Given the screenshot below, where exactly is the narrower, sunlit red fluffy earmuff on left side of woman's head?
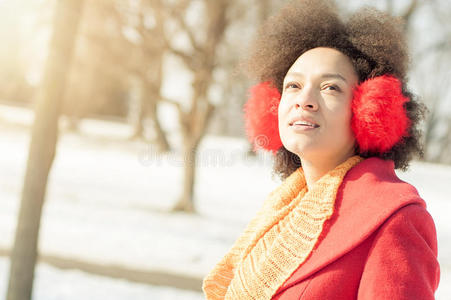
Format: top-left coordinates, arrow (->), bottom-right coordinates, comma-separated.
244,81 -> 282,153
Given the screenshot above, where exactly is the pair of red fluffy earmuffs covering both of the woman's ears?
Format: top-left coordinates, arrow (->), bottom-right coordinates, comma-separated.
244,75 -> 410,153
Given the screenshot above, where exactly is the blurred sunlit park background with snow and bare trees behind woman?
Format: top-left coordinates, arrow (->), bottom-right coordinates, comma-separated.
0,0 -> 451,300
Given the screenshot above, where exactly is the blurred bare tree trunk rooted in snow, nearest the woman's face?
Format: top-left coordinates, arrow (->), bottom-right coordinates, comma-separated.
168,0 -> 229,213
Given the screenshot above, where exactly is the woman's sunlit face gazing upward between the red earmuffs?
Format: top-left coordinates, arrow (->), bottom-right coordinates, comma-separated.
278,47 -> 358,161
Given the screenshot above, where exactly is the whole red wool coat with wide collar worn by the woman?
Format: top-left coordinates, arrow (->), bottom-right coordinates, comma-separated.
272,158 -> 440,300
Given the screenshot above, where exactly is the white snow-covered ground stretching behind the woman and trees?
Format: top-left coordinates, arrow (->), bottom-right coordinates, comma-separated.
0,106 -> 451,300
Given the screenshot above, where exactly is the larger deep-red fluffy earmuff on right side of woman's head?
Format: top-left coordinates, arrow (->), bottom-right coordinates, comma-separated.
351,75 -> 410,153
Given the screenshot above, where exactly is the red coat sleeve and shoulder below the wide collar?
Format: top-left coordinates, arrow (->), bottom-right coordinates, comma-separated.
358,204 -> 440,300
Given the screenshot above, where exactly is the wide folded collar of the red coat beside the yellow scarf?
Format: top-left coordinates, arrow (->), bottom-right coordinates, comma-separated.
276,158 -> 426,294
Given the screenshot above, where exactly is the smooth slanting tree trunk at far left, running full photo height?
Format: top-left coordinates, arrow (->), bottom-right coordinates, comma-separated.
7,0 -> 83,300
